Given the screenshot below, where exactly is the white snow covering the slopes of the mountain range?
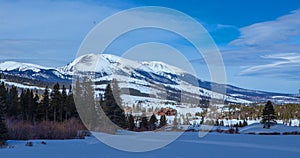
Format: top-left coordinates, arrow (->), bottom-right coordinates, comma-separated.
0,54 -> 299,104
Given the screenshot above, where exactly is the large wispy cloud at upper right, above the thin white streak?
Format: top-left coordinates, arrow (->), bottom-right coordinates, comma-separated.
230,10 -> 300,46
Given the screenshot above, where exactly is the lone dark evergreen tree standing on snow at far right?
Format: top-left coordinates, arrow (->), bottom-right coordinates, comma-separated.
261,101 -> 275,128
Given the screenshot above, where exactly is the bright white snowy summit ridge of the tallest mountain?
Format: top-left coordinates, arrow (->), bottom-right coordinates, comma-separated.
58,54 -> 187,74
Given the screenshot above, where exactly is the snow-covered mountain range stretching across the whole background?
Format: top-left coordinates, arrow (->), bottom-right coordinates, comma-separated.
0,54 -> 298,103
